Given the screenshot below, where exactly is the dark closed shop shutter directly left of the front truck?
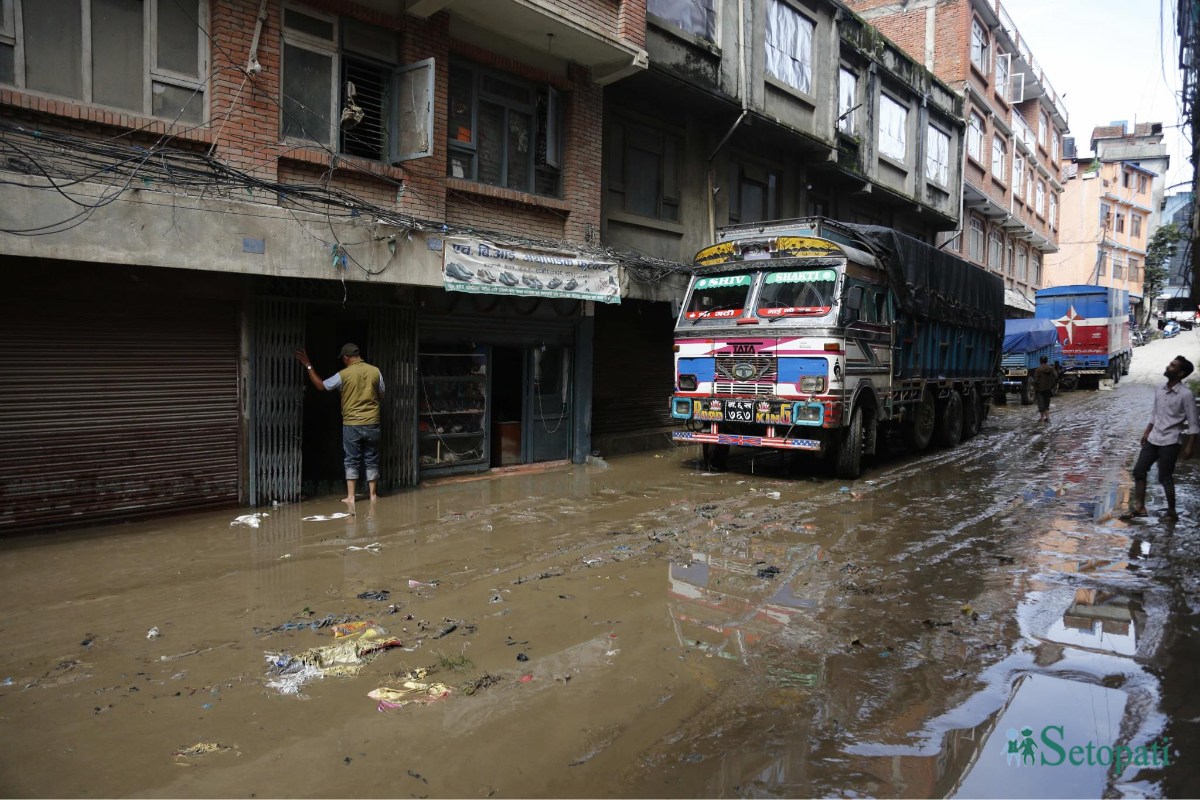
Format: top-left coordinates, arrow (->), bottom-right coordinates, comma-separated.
592,300 -> 674,438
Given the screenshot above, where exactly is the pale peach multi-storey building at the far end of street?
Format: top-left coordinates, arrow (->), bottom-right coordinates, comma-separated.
1045,122 -> 1169,315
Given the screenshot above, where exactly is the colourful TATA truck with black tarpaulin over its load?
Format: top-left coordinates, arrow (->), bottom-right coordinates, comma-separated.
670,217 -> 1004,479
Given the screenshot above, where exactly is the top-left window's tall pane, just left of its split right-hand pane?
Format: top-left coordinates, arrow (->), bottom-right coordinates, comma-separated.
91,0 -> 145,114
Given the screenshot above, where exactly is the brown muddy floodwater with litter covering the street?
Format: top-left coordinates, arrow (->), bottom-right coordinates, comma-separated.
0,333 -> 1200,798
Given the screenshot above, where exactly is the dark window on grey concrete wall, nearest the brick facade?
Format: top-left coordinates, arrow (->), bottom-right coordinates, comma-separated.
606,121 -> 683,222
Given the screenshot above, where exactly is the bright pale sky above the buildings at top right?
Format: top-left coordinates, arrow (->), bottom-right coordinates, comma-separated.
1001,0 -> 1192,192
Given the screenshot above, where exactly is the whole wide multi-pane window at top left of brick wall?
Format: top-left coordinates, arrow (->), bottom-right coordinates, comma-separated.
0,0 -> 208,125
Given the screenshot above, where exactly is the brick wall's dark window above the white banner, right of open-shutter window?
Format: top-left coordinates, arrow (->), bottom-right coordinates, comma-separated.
446,64 -> 562,197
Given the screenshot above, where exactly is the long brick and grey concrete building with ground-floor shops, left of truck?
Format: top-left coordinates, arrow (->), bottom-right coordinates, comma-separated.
0,0 -> 964,533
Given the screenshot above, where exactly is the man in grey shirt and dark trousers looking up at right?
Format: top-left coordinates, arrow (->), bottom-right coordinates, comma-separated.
1129,355 -> 1200,522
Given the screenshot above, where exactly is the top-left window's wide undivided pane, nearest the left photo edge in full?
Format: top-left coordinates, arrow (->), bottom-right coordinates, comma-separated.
22,0 -> 83,100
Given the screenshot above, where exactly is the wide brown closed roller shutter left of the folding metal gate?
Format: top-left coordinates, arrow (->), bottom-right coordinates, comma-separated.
0,294 -> 239,534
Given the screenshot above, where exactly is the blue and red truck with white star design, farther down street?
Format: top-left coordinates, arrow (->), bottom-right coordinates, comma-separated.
1033,284 -> 1133,387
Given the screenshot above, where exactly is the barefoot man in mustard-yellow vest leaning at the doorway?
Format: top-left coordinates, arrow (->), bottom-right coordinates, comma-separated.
295,342 -> 384,513
